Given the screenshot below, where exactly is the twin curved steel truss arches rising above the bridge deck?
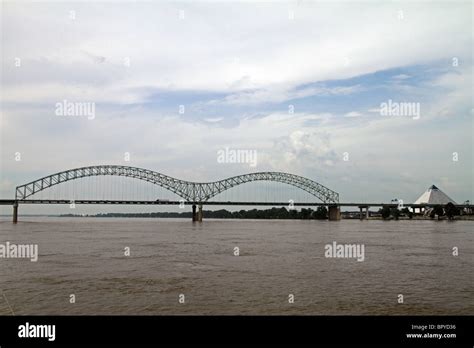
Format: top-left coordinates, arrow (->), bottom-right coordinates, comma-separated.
15,165 -> 339,204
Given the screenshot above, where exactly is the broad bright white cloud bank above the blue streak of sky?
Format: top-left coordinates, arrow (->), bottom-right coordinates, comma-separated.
2,2 -> 470,103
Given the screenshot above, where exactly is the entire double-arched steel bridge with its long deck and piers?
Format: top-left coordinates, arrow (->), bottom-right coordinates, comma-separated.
0,165 -> 470,223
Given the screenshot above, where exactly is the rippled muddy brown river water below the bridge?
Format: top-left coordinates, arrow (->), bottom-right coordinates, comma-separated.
0,217 -> 474,315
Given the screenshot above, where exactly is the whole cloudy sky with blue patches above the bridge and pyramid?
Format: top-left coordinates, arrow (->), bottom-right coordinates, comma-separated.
0,1 -> 474,212
